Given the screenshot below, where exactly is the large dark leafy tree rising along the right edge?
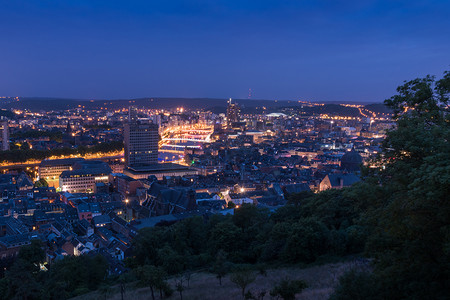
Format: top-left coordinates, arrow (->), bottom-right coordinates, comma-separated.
365,72 -> 450,299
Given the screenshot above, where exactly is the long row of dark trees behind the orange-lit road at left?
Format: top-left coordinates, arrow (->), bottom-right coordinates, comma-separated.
0,141 -> 123,163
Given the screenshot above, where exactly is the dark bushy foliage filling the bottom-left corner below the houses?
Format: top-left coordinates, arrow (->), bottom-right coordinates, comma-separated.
0,240 -> 107,299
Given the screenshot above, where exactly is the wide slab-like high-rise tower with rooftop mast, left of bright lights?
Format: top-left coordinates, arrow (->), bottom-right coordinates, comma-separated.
124,107 -> 159,167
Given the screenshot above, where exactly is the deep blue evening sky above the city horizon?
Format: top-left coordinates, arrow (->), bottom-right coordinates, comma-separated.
0,0 -> 450,102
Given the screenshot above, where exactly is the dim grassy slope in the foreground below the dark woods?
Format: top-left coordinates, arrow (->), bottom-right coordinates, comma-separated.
73,261 -> 370,300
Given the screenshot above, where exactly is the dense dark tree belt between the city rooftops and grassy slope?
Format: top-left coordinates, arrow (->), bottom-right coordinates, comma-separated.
128,189 -> 372,274
